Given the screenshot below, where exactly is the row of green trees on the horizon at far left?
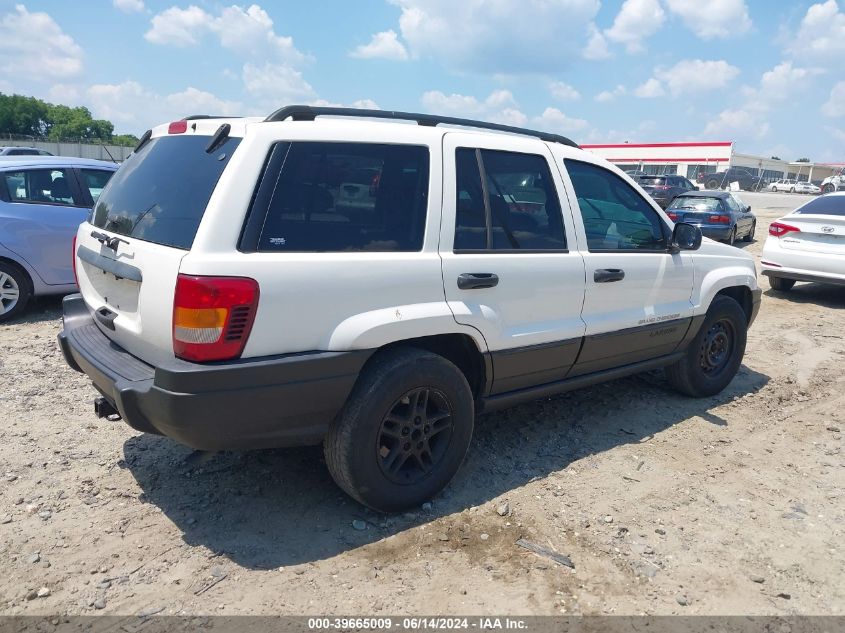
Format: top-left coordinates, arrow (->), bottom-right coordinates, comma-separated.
0,92 -> 138,146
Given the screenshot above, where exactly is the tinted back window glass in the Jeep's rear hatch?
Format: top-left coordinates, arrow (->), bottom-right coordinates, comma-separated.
92,135 -> 240,250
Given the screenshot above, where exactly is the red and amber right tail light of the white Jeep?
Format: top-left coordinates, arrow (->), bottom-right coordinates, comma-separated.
173,275 -> 259,362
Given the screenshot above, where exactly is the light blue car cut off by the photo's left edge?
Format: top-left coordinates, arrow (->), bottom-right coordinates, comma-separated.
0,156 -> 117,322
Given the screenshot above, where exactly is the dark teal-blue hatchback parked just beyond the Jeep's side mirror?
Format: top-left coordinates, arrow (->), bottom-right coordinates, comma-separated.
666,190 -> 757,244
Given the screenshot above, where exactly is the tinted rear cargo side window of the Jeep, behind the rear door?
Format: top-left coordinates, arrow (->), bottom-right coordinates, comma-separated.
258,142 -> 429,252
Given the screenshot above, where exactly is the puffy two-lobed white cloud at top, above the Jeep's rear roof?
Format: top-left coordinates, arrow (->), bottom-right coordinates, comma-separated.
144,4 -> 307,64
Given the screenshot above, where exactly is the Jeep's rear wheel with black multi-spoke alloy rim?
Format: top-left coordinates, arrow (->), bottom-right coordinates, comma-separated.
324,347 -> 475,512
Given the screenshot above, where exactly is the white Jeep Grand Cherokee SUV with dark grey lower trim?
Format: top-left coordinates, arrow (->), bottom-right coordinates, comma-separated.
59,106 -> 760,511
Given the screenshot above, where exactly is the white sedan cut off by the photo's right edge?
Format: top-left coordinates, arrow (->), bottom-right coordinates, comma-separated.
761,191 -> 845,291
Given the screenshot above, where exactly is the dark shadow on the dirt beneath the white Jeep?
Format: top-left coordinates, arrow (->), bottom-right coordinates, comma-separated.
121,366 -> 769,569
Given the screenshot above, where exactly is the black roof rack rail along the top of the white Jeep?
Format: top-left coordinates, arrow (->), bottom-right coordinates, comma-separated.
264,105 -> 578,147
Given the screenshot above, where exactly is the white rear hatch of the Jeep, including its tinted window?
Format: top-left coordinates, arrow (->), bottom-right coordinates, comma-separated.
75,120 -> 244,363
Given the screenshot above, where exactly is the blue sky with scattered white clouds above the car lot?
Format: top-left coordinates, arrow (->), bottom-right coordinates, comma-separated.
0,0 -> 845,162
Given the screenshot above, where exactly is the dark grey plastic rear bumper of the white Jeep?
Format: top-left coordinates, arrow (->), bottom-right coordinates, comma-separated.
59,294 -> 372,450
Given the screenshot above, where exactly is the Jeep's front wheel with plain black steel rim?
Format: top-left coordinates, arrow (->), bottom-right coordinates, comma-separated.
666,295 -> 748,398
